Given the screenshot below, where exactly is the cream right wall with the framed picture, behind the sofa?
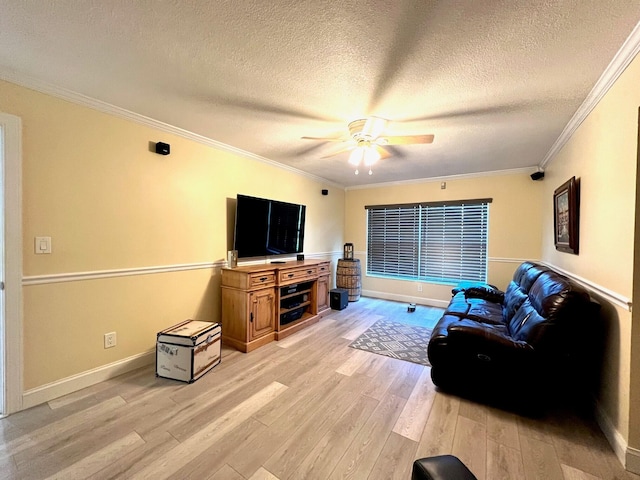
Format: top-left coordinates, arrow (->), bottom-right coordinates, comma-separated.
542,54 -> 640,448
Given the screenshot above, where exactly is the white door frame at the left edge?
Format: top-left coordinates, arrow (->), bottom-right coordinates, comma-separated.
0,112 -> 23,415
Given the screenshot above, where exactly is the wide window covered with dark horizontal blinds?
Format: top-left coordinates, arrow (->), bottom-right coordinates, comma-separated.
365,199 -> 491,283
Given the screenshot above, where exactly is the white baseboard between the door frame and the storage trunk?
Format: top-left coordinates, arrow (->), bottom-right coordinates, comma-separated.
22,348 -> 155,410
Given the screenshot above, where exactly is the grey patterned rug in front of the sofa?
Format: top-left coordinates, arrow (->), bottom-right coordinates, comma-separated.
349,320 -> 431,366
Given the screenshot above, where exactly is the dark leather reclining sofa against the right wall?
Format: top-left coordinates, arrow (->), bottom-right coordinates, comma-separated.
428,262 -> 599,406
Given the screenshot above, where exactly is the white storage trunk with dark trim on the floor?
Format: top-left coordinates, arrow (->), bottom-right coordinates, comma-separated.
156,320 -> 221,383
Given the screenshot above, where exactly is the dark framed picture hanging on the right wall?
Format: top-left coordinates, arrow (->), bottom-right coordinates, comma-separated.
553,177 -> 580,255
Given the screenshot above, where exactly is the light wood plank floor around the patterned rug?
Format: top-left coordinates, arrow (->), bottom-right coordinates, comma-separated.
0,298 -> 640,480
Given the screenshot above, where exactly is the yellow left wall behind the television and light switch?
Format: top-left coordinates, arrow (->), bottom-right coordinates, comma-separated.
0,82 -> 344,389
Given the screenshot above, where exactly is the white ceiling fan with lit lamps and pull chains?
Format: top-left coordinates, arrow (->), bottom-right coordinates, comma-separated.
302,117 -> 433,175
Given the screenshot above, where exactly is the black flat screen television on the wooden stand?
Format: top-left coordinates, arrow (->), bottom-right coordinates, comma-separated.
233,195 -> 307,258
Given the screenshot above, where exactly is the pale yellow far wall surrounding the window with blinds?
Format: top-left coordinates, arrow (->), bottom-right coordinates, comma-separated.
345,173 -> 544,305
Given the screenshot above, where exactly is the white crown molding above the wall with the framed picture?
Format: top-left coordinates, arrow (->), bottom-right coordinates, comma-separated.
540,23 -> 640,168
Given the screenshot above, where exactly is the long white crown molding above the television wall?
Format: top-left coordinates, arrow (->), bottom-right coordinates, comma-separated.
0,67 -> 344,188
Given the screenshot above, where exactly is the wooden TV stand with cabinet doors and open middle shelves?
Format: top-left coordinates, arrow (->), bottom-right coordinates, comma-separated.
221,260 -> 331,353
